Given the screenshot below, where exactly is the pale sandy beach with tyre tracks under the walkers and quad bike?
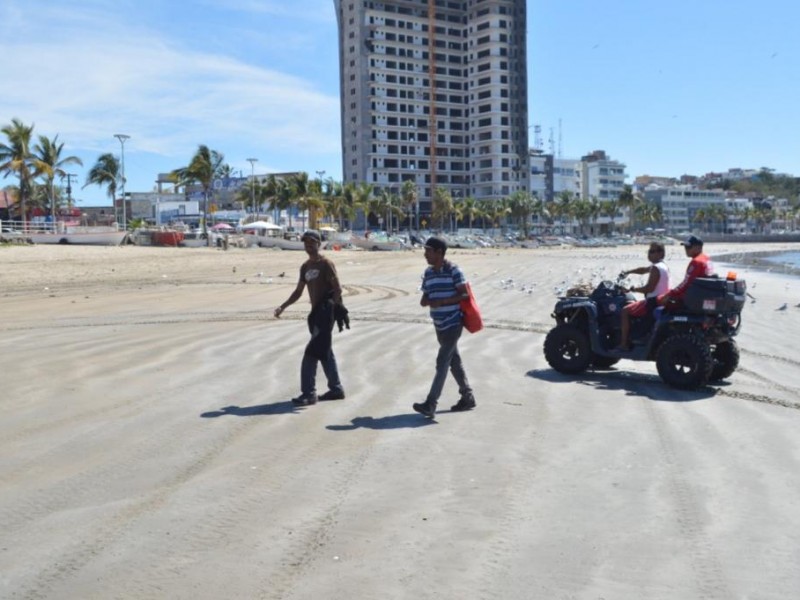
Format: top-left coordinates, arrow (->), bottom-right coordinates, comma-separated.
0,244 -> 800,600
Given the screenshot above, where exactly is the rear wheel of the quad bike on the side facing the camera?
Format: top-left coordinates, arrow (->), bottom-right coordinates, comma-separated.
656,333 -> 714,389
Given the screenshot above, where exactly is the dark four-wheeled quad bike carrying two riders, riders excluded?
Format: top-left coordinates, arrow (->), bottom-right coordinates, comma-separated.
544,274 -> 747,389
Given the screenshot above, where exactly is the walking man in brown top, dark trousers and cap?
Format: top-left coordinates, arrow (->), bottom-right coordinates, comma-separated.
275,230 -> 344,406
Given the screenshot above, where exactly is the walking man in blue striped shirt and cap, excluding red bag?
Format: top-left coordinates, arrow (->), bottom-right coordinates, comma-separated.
413,237 -> 475,418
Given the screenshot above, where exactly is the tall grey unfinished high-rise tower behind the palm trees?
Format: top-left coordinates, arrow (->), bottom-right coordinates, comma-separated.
334,0 -> 529,219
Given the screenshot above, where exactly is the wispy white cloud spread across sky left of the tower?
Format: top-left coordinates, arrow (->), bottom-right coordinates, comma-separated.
0,2 -> 339,161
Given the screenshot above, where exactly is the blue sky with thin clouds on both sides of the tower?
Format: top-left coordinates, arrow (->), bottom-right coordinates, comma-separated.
0,0 -> 800,204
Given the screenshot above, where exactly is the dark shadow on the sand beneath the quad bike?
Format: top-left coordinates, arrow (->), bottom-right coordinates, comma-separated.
526,369 -> 724,402
